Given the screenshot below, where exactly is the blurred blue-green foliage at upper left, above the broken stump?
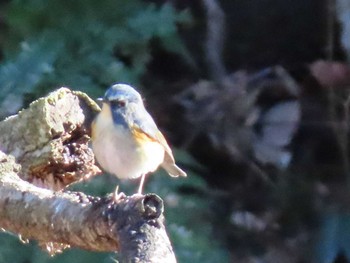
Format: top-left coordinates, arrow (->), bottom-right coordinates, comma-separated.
0,0 -> 191,115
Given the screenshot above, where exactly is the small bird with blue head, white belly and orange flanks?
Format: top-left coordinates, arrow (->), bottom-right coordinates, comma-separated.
92,84 -> 186,194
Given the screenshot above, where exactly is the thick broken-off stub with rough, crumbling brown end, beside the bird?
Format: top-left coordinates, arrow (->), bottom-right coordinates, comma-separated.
0,88 -> 99,190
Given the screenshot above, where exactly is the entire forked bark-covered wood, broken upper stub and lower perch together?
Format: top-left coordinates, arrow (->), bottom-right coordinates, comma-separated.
0,88 -> 176,262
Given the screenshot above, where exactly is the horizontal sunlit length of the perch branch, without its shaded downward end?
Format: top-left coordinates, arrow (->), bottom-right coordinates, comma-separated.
0,153 -> 118,251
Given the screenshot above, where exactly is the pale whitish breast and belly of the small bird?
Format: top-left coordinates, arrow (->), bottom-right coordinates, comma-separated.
92,115 -> 164,179
